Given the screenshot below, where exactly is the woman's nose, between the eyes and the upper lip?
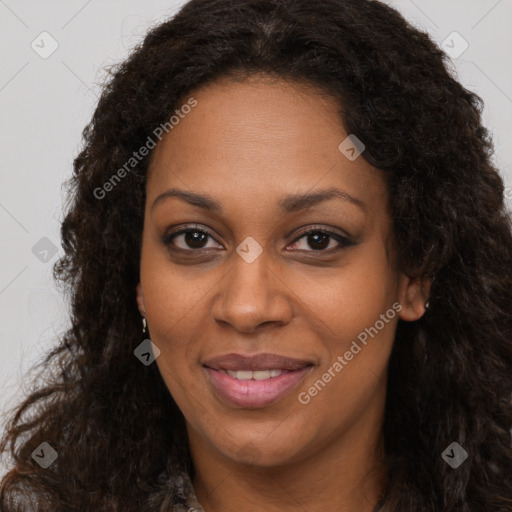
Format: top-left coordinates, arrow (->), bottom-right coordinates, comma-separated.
212,251 -> 293,333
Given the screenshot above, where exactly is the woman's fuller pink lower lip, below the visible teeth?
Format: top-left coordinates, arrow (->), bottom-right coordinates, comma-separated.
205,366 -> 312,408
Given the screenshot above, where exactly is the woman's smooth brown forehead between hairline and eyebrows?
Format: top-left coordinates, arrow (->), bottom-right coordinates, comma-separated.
147,74 -> 387,214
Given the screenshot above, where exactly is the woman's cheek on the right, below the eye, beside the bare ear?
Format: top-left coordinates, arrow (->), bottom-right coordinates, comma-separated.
298,240 -> 400,396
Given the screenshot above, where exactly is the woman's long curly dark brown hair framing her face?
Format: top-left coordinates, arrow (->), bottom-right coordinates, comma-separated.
0,0 -> 512,512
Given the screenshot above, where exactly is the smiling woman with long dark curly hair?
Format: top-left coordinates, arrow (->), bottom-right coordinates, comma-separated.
0,0 -> 512,512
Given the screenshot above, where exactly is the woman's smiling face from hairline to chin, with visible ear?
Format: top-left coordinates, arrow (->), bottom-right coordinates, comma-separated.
137,75 -> 426,466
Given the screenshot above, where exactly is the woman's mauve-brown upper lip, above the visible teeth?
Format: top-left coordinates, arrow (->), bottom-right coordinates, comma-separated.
203,353 -> 313,370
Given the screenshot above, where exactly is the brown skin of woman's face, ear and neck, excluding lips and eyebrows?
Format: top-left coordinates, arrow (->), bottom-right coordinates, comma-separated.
137,76 -> 430,512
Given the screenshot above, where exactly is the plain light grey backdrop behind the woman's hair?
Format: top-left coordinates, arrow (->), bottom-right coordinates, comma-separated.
0,0 -> 512,475
